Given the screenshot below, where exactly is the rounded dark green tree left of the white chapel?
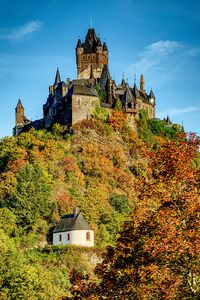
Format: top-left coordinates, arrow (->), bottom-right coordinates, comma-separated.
7,163 -> 52,231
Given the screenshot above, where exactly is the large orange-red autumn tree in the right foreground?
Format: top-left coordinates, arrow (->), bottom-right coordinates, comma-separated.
70,135 -> 200,300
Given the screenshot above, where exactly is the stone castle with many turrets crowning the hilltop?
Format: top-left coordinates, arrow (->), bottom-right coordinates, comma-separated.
13,28 -> 155,135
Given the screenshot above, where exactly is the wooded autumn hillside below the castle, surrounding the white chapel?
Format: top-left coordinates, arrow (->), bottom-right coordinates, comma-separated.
0,108 -> 199,299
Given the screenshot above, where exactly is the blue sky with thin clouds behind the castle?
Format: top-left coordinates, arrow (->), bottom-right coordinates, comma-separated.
0,0 -> 200,137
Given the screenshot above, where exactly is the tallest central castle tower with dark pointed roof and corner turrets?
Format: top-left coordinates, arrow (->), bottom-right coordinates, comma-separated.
76,28 -> 108,79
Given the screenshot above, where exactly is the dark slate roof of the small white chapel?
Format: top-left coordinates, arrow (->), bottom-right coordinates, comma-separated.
53,212 -> 93,233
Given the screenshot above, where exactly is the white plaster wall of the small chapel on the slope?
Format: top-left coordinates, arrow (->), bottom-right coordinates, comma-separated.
53,230 -> 94,247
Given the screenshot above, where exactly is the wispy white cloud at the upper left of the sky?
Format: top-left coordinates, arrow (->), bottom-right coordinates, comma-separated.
0,21 -> 42,41
